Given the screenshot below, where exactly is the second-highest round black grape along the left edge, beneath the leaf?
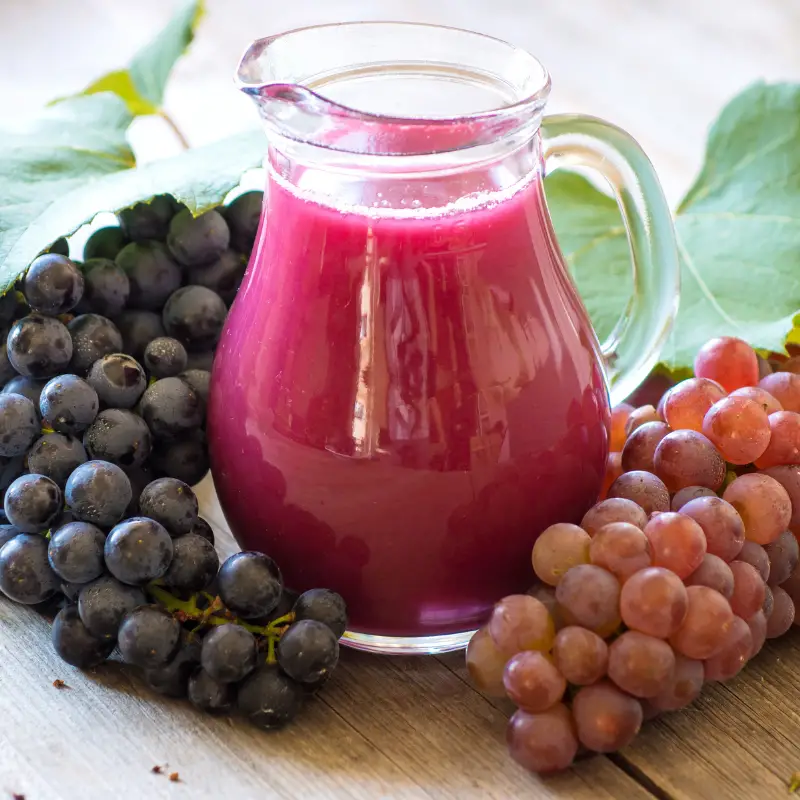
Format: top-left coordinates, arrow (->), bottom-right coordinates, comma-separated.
7,314 -> 72,378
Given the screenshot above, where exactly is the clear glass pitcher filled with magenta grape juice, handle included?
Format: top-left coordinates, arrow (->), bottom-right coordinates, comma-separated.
208,23 -> 678,653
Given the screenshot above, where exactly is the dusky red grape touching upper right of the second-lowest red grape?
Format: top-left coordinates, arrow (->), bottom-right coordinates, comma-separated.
608,631 -> 675,697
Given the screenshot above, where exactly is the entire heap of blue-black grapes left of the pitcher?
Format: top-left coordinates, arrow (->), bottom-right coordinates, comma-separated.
0,192 -> 347,729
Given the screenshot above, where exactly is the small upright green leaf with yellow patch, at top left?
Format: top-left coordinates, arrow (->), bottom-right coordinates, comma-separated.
66,0 -> 205,116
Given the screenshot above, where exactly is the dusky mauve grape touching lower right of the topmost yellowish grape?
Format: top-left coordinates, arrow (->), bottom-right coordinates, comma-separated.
556,564 -> 621,638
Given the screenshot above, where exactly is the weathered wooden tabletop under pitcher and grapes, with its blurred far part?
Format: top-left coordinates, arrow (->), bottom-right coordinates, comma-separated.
0,0 -> 800,800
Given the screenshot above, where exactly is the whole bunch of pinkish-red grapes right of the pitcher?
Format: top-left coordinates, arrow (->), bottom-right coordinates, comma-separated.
467,337 -> 800,773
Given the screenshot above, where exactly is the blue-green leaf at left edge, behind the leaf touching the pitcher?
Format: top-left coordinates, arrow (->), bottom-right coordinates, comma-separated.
0,94 -> 135,284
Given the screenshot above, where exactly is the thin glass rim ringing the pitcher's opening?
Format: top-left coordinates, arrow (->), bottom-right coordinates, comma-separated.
234,20 -> 552,127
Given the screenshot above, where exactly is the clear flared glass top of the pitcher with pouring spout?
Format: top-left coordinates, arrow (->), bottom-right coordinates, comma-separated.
236,22 -> 550,156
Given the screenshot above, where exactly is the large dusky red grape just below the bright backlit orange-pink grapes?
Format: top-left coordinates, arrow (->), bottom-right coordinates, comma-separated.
653,430 -> 725,493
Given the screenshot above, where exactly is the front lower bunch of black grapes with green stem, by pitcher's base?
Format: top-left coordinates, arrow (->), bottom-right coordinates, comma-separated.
0,461 -> 347,728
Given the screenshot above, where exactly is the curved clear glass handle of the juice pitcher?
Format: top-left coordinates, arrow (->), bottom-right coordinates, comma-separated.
542,114 -> 680,406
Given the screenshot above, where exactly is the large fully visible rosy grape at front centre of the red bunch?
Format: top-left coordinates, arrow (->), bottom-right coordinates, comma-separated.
619,567 -> 689,639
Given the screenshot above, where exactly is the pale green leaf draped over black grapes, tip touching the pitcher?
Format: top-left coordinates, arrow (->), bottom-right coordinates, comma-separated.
0,128 -> 266,293
